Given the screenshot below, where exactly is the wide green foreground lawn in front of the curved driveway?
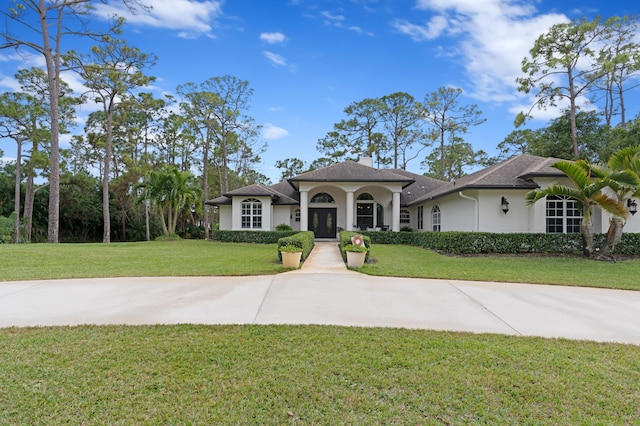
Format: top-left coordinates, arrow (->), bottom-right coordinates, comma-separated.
0,325 -> 640,425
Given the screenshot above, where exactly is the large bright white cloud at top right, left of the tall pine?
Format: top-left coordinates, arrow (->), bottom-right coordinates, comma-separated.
396,0 -> 568,102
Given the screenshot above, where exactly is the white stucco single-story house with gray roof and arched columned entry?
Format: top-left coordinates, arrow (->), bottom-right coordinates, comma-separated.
207,155 -> 640,238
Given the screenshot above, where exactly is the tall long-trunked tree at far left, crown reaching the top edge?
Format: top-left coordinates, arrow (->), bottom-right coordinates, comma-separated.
0,0 -> 144,243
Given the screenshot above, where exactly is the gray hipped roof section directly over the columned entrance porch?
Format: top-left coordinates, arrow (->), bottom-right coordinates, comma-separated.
289,161 -> 415,189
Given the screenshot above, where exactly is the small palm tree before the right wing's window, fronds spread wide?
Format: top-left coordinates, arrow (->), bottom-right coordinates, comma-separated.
526,160 -> 627,256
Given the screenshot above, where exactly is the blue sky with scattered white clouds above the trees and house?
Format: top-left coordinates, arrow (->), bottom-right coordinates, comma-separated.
0,0 -> 640,182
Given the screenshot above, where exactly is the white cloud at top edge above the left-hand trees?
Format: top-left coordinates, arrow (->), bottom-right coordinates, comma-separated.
95,0 -> 222,38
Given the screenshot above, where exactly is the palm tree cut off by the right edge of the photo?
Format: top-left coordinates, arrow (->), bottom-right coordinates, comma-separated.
592,145 -> 640,256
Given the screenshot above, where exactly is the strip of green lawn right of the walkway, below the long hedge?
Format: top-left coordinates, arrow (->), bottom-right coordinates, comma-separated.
359,244 -> 640,290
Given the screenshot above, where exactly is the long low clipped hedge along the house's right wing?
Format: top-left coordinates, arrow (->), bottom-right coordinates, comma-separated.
361,232 -> 640,256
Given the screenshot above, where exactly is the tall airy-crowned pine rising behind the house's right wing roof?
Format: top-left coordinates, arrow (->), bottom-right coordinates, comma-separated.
515,17 -> 604,158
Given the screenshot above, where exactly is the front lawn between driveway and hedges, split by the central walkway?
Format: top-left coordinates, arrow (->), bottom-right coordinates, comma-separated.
0,240 -> 640,290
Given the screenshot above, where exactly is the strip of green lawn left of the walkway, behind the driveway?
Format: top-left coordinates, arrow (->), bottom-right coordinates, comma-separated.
0,240 -> 284,281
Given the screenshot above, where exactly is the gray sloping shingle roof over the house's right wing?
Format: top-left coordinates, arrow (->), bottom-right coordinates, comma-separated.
409,154 -> 564,204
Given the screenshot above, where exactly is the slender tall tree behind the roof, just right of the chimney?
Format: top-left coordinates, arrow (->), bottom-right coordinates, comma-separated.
423,87 -> 486,180
